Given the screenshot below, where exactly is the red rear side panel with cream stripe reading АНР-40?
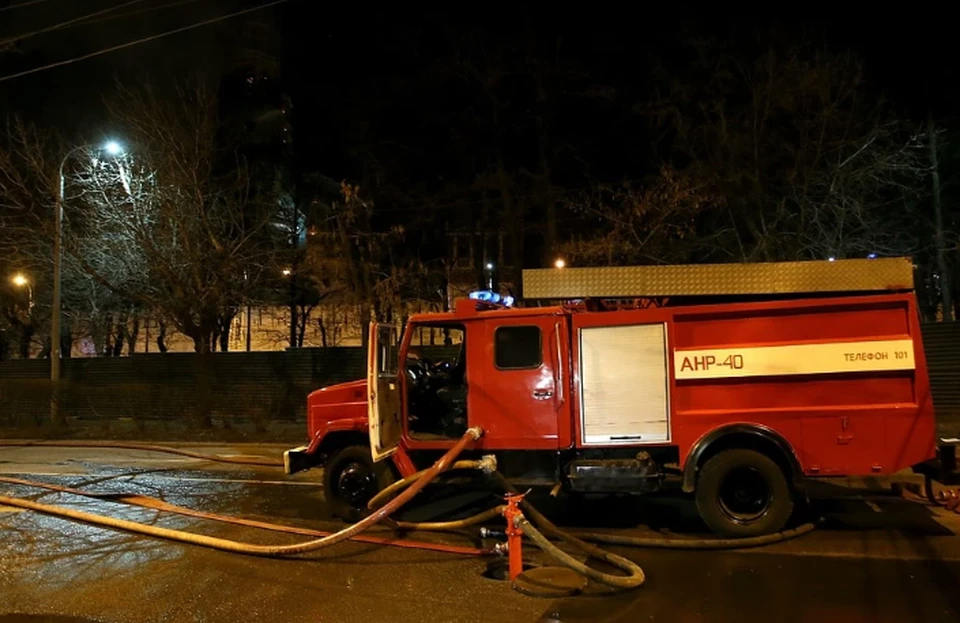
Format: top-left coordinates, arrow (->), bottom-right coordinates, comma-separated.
672,295 -> 934,475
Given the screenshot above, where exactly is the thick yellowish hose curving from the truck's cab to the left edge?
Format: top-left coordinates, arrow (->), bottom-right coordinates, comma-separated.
0,428 -> 483,556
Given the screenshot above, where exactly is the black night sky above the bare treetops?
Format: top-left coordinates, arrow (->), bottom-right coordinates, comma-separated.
0,0 -> 960,177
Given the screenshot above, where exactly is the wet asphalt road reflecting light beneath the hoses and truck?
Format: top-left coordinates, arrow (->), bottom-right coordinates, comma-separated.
0,448 -> 960,623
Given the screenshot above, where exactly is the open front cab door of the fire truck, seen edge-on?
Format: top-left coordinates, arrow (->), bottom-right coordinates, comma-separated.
367,323 -> 403,461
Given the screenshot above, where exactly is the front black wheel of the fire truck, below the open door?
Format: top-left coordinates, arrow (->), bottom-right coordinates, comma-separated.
323,446 -> 396,522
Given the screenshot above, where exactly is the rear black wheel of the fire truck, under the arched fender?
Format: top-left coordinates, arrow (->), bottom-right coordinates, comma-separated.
695,450 -> 793,538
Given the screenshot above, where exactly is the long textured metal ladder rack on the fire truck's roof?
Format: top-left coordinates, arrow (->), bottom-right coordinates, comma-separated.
523,257 -> 913,300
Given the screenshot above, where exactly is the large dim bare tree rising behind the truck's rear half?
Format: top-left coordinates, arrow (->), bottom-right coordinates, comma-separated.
643,40 -> 928,261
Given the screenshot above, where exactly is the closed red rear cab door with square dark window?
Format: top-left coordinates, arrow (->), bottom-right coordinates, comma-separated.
469,316 -> 570,450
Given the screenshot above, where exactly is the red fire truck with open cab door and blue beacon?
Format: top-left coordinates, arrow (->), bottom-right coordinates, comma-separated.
285,258 -> 956,536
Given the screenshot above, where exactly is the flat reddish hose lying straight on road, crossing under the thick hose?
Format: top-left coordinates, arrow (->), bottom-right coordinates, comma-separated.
0,476 -> 493,556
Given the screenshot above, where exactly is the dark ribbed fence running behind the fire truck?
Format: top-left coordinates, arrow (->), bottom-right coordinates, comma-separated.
0,322 -> 960,436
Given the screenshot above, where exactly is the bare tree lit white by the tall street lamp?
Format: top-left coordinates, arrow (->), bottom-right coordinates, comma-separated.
64,79 -> 275,353
